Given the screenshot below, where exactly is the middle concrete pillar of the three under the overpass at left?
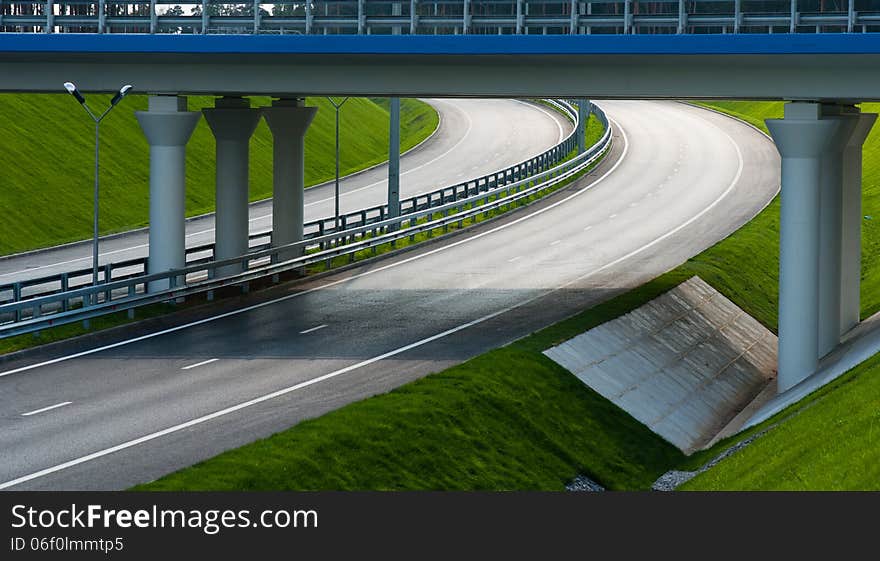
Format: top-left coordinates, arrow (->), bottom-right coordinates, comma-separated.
202,97 -> 260,277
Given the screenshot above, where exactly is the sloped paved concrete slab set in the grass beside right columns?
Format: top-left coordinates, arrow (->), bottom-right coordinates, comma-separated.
544,277 -> 777,454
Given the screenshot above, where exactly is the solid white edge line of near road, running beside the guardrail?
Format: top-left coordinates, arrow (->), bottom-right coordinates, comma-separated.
0,112 -> 629,378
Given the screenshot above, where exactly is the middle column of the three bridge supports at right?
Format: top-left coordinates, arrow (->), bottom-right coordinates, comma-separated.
818,105 -> 858,358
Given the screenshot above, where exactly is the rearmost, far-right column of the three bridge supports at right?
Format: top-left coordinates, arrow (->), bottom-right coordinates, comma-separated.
840,110 -> 877,335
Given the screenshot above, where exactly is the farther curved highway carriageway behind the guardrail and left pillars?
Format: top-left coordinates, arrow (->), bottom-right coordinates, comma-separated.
0,99 -> 571,284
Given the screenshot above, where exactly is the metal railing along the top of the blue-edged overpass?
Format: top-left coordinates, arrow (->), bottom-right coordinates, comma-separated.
0,0 -> 880,35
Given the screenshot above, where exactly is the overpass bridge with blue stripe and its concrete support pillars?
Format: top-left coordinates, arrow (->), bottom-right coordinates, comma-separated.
0,14 -> 880,398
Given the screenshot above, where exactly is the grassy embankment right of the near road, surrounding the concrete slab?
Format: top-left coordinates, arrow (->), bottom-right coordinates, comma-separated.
141,103 -> 880,489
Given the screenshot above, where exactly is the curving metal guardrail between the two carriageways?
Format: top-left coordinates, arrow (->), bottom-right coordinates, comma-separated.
0,100 -> 611,338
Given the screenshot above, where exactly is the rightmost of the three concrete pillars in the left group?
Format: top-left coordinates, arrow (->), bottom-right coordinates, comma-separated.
263,99 -> 318,261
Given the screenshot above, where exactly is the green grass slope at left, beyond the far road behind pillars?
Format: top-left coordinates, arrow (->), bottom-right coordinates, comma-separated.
0,94 -> 438,255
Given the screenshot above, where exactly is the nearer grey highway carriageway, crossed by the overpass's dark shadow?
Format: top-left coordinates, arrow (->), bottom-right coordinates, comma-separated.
0,101 -> 779,489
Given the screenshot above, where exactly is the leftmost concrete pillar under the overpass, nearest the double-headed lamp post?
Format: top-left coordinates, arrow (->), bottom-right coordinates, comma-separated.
135,95 -> 202,292
